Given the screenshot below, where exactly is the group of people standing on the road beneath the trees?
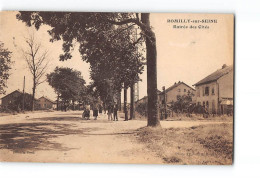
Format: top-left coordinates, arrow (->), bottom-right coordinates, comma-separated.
82,104 -> 118,121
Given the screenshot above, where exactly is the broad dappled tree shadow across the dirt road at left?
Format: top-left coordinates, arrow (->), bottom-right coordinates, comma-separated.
0,118 -> 98,153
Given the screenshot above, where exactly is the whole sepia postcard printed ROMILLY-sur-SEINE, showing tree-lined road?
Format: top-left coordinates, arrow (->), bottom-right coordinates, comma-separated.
0,11 -> 234,165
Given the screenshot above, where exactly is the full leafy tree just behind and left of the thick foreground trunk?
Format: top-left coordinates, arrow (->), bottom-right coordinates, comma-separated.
88,22 -> 144,120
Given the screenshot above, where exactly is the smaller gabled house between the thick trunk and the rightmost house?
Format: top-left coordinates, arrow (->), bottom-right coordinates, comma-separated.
159,81 -> 195,104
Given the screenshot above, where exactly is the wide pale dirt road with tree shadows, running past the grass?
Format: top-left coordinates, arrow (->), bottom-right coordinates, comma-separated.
0,111 -> 230,164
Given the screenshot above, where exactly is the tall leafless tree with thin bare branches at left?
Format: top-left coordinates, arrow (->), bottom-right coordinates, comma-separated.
22,33 -> 48,111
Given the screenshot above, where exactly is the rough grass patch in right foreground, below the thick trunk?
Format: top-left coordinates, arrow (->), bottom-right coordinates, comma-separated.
137,123 -> 233,165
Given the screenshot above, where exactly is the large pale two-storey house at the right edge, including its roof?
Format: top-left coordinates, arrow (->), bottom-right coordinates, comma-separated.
194,65 -> 233,114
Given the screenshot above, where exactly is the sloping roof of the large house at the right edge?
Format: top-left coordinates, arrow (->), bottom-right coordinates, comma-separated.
194,65 -> 233,86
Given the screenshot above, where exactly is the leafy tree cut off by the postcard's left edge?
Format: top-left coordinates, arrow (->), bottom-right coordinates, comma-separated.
0,41 -> 12,94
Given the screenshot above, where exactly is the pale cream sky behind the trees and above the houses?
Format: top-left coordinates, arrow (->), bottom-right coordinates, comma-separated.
0,11 -> 233,100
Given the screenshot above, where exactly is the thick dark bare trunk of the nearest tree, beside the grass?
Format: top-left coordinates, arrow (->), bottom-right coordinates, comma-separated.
141,13 -> 160,127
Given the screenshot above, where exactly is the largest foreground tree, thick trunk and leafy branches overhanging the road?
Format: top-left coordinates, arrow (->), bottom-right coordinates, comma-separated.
17,12 -> 160,126
